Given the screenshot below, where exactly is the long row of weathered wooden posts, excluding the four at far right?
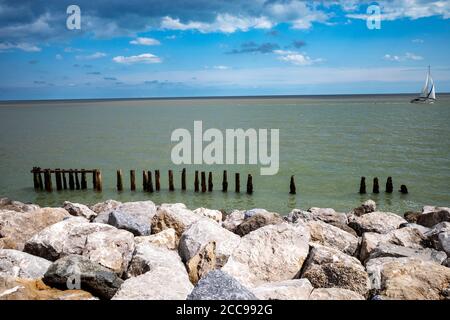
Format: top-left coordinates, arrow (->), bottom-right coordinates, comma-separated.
31,167 -> 296,194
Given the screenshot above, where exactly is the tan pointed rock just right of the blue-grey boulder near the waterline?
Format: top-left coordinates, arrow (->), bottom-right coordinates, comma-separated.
152,205 -> 206,242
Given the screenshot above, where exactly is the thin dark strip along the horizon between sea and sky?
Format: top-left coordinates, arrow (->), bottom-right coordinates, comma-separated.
0,92 -> 450,105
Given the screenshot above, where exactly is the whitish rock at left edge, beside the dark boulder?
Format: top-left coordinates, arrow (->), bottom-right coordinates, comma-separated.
0,249 -> 51,279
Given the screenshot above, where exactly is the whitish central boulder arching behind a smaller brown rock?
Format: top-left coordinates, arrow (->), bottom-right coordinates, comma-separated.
178,219 -> 241,267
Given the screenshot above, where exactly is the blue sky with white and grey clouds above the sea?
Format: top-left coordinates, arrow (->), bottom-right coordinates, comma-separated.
0,0 -> 450,100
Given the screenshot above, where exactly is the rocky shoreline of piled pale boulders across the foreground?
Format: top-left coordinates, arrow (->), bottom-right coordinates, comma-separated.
0,198 -> 450,300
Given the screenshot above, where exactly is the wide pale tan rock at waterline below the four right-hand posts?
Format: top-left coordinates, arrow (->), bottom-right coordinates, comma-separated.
349,211 -> 406,235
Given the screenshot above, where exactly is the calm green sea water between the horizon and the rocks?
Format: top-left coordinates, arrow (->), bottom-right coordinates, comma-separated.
0,95 -> 450,214
